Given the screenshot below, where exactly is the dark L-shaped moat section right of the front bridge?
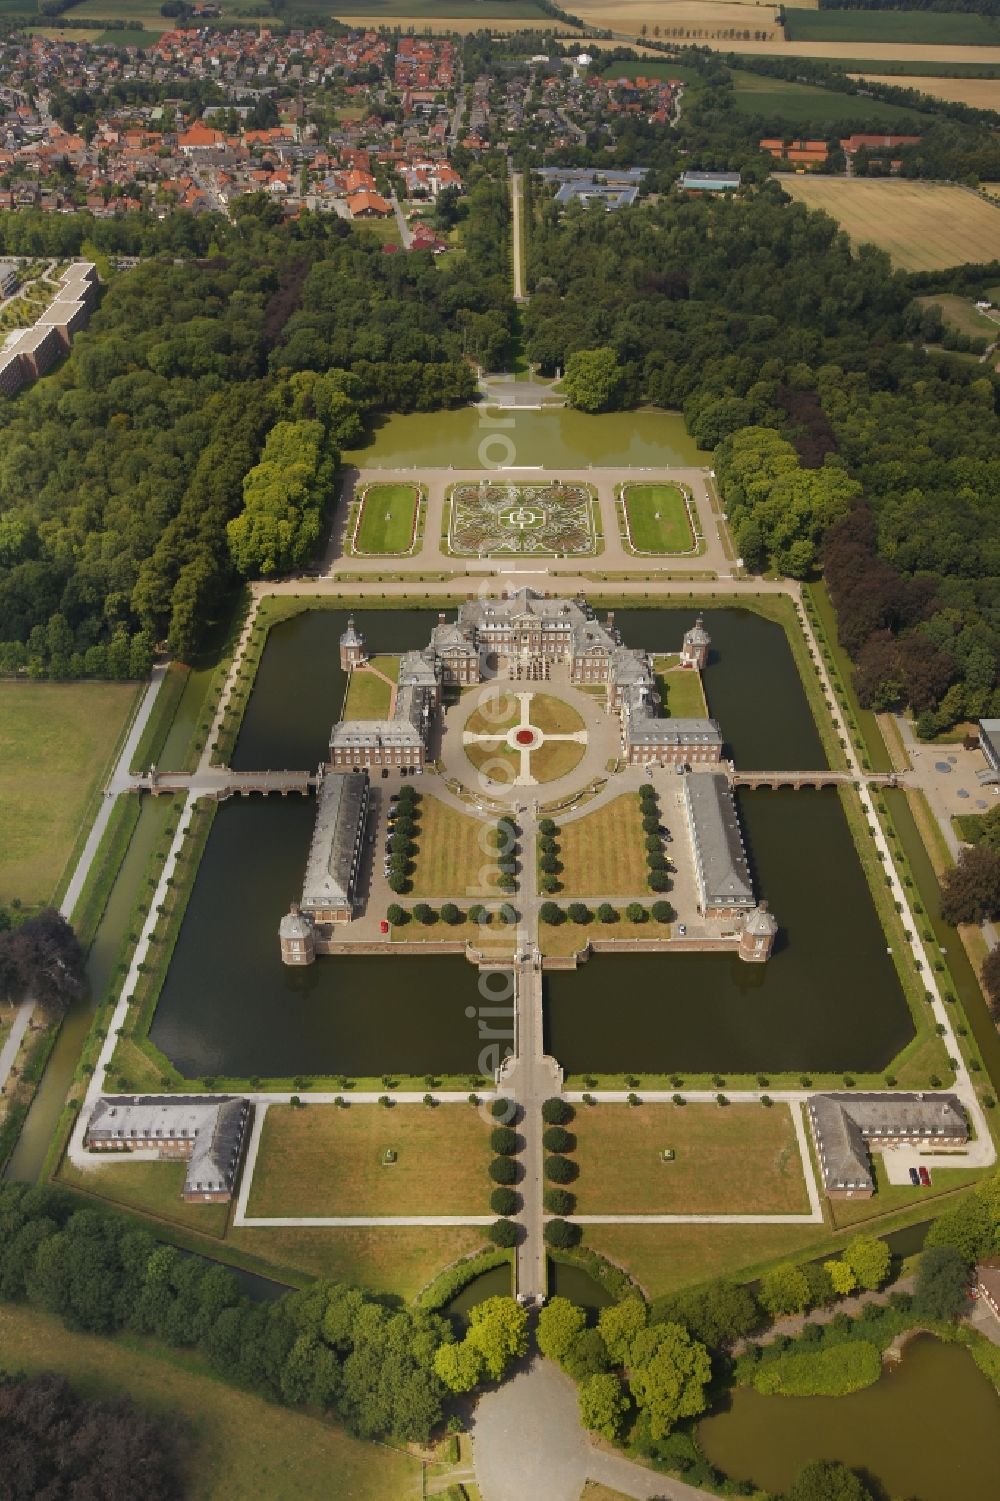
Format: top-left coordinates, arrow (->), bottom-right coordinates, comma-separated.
545,790 -> 913,1075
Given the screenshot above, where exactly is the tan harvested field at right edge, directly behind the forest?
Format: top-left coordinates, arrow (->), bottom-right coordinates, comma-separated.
781,174 -> 1000,272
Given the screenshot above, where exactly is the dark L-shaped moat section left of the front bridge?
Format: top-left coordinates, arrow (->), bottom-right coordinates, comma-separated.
150,797 -> 495,1078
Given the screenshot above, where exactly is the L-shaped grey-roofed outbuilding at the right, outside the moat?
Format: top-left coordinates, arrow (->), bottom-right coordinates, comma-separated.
808,1094 -> 968,1199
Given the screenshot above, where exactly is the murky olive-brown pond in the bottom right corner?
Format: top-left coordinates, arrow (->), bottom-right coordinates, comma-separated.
698,1334 -> 1000,1501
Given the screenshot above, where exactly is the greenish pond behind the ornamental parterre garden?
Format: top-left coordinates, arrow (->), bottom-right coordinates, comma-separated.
344,407 -> 696,470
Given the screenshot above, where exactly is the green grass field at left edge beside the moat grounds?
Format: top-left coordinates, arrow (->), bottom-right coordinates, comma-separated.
0,681 -> 137,907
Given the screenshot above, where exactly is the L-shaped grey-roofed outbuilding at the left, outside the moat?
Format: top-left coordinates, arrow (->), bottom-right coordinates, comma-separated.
84,1094 -> 251,1204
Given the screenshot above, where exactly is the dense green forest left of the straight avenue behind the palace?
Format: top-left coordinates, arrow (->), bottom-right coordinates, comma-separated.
0,176 -> 512,677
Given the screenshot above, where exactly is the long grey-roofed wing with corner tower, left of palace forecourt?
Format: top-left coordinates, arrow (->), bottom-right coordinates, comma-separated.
278,772 -> 369,964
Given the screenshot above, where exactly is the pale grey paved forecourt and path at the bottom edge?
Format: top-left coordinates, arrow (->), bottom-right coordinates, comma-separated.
471,1355 -> 707,1501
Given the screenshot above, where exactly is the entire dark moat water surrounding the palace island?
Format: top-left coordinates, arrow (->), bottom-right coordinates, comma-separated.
152,606 -> 911,1078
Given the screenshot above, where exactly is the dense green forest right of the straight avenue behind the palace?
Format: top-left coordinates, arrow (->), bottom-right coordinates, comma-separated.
524,183 -> 1000,734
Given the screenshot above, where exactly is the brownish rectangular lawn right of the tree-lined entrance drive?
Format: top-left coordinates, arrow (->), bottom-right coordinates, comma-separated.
571,1105 -> 809,1214
